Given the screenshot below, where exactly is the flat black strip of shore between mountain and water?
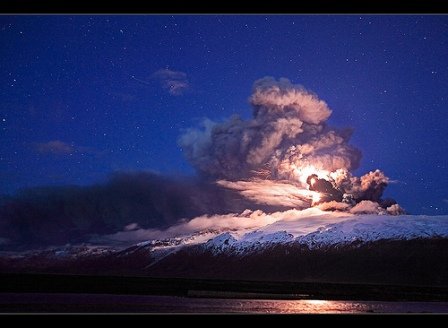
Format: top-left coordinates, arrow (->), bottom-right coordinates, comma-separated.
0,273 -> 448,302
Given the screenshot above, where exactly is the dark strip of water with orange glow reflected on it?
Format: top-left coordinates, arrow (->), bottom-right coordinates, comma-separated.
0,293 -> 448,314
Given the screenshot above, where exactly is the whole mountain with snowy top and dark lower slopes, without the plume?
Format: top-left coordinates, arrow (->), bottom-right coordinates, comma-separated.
0,208 -> 448,284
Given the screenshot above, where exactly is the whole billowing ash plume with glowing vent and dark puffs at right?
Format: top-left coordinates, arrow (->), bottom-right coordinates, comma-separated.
179,77 -> 404,214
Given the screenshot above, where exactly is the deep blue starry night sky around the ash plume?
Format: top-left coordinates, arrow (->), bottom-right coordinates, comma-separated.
0,15 -> 448,214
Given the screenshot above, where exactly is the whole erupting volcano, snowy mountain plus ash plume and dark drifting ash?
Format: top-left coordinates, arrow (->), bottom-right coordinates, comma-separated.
0,77 -> 448,292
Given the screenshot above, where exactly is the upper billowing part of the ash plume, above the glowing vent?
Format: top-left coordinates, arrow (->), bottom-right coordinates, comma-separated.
179,77 -> 361,180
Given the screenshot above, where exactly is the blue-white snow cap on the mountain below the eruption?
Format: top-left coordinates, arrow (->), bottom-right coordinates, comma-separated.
204,210 -> 448,252
